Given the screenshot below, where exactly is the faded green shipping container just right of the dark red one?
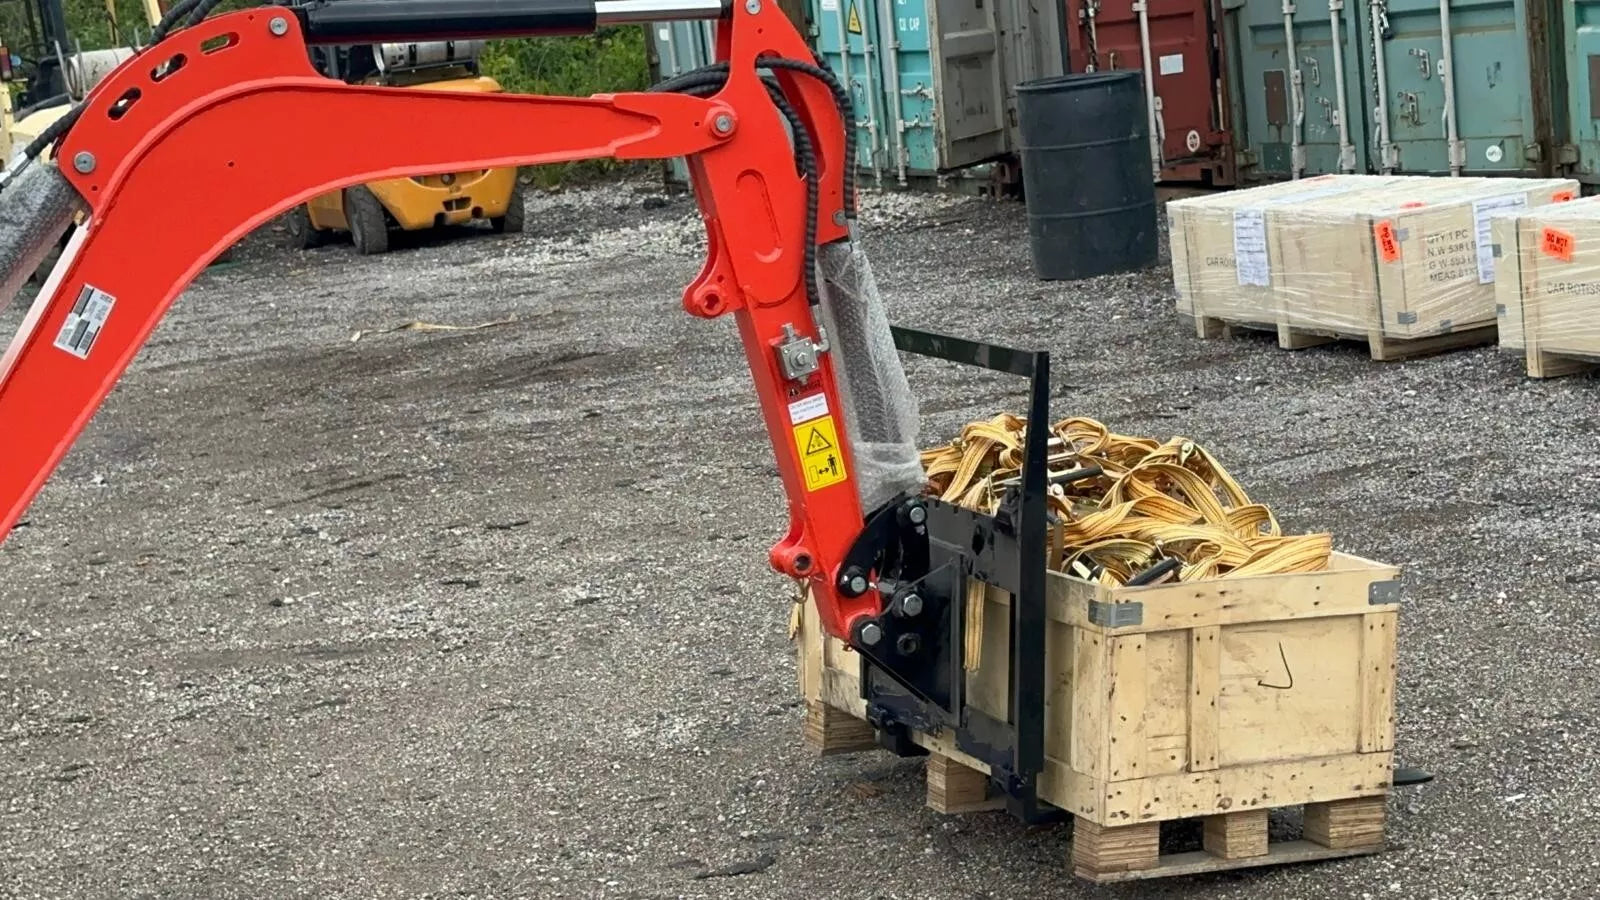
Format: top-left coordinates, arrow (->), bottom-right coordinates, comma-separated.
1222,0 -> 1571,181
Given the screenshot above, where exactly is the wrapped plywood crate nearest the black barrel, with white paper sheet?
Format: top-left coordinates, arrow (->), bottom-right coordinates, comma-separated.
1166,175 -> 1402,323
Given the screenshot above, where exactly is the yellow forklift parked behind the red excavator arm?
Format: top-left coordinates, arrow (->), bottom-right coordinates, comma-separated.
286,40 -> 523,253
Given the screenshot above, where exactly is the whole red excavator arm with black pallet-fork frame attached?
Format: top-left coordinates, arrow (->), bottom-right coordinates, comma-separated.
0,0 -> 1075,817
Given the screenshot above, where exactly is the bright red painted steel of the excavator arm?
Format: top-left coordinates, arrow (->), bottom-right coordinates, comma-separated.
0,3 -> 882,637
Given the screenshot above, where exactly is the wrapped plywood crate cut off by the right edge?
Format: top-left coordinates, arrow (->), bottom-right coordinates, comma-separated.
1493,197 -> 1600,378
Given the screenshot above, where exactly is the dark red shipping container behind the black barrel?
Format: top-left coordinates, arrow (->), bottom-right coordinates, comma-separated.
1064,0 -> 1234,186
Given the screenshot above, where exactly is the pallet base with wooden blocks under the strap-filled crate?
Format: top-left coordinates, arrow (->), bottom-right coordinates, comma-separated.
805,705 -> 1387,884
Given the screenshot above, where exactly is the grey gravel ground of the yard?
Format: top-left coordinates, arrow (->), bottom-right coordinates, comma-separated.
0,175 -> 1600,900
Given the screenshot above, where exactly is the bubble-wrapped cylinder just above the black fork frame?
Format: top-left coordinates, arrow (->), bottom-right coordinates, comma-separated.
818,240 -> 926,512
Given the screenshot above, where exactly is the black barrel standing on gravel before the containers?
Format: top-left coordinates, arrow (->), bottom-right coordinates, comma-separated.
1016,70 -> 1160,280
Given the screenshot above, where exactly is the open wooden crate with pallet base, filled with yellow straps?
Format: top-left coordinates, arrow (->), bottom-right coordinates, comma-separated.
798,554 -> 1398,881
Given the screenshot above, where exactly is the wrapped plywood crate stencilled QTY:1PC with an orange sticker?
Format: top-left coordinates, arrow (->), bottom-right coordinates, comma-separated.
1269,178 -> 1578,359
